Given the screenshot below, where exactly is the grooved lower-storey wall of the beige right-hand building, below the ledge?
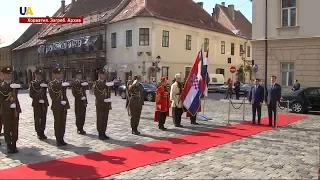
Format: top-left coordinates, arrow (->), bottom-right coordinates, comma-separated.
252,38 -> 320,87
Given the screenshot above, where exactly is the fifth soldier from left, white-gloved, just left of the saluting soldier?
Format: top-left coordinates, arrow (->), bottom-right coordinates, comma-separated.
94,69 -> 113,140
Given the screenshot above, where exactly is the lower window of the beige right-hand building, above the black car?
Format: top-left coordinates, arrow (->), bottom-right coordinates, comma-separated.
280,63 -> 294,86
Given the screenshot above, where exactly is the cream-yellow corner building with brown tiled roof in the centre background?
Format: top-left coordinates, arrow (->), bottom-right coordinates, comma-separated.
106,0 -> 251,81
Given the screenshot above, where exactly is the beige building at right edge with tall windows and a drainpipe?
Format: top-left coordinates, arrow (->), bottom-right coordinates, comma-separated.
252,0 -> 320,89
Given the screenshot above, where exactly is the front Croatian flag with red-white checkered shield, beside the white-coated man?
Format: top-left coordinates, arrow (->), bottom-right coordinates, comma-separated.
181,51 -> 203,116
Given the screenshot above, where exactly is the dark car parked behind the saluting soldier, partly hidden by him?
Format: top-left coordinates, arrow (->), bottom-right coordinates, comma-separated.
118,82 -> 157,102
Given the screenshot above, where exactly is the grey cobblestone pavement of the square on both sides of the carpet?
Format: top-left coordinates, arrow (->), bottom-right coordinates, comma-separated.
0,92 -> 320,179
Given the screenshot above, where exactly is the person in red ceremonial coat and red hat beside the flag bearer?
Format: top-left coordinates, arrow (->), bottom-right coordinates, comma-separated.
154,77 -> 170,131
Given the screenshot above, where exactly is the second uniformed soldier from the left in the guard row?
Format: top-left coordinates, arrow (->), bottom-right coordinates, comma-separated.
29,69 -> 49,140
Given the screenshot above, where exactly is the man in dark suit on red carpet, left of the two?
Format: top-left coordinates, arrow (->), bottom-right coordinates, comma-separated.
249,79 -> 264,124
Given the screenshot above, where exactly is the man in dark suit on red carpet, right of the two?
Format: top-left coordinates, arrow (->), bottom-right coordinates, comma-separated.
267,76 -> 281,126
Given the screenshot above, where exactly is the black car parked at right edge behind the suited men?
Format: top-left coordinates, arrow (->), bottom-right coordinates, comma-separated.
280,87 -> 320,113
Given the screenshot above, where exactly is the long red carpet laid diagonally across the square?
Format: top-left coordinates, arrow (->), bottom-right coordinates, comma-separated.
0,115 -> 306,179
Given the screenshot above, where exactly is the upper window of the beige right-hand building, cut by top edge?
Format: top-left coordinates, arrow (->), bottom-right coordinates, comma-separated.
281,0 -> 297,27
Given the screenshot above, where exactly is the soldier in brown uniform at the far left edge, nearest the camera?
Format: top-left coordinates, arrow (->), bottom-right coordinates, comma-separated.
0,67 -> 21,153
